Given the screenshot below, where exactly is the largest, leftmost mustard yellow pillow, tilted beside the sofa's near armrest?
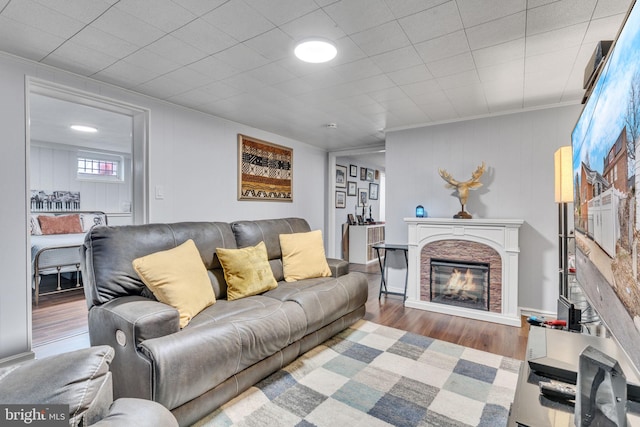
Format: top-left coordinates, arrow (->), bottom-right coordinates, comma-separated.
133,239 -> 216,328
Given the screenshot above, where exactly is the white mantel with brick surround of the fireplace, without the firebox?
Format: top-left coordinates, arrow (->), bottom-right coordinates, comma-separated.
404,218 -> 524,327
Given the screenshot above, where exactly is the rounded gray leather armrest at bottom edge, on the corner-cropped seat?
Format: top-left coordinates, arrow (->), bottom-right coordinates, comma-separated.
92,398 -> 178,427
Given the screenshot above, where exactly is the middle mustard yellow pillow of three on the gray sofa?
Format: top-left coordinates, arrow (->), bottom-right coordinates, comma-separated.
216,242 -> 278,301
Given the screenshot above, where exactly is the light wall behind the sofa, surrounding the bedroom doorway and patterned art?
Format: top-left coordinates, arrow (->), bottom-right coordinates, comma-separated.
0,54 -> 327,363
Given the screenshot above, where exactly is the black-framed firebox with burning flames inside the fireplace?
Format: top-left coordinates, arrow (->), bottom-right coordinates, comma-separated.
430,258 -> 489,311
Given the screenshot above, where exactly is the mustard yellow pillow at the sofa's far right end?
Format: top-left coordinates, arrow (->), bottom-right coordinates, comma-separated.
280,230 -> 331,282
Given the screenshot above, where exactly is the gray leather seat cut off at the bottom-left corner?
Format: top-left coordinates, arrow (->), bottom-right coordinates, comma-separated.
0,346 -> 178,427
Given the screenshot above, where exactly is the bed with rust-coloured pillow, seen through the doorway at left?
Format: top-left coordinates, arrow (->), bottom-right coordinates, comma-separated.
29,211 -> 107,305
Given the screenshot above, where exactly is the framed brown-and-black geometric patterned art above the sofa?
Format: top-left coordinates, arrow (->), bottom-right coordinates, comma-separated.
238,134 -> 293,202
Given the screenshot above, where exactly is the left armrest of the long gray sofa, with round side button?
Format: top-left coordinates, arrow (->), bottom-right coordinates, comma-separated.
89,296 -> 180,400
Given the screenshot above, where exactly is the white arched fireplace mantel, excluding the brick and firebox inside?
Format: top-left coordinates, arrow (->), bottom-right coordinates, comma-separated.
404,218 -> 524,326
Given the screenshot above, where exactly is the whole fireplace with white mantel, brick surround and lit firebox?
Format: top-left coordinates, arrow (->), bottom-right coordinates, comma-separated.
404,218 -> 524,327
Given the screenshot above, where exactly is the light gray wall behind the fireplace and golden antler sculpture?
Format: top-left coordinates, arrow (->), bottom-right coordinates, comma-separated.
385,105 -> 582,313
